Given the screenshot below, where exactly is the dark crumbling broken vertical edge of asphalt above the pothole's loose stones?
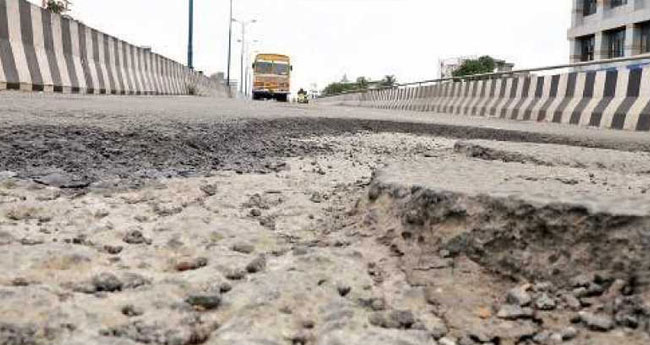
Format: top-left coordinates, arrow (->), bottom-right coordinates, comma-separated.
360,184 -> 650,290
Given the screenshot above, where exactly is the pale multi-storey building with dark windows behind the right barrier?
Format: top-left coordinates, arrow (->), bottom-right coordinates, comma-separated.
568,0 -> 650,63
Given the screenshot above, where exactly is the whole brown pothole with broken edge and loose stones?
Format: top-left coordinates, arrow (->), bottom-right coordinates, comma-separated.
352,179 -> 650,344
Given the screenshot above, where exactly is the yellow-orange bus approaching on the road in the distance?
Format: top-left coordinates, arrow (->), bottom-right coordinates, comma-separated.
253,54 -> 293,102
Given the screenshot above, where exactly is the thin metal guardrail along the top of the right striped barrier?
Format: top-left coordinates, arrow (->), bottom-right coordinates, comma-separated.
319,53 -> 650,98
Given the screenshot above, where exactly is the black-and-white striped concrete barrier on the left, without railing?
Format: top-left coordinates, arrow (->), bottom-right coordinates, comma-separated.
0,0 -> 225,95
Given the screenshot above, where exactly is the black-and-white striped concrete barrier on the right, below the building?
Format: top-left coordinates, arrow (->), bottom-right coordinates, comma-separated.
317,67 -> 650,131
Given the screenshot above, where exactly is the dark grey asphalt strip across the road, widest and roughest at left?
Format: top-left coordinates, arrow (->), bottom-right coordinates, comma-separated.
0,118 -> 650,188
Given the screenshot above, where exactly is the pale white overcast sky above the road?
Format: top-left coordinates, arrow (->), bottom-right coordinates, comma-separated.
30,0 -> 571,91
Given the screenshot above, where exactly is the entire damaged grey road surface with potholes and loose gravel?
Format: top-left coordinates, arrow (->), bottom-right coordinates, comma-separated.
0,94 -> 650,345
